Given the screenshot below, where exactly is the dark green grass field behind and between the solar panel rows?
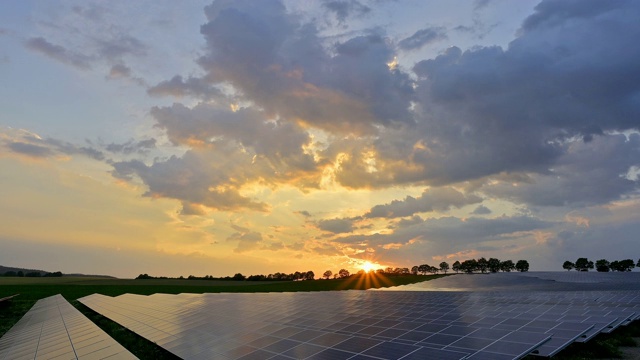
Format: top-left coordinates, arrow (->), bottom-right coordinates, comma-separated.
0,275 -> 447,359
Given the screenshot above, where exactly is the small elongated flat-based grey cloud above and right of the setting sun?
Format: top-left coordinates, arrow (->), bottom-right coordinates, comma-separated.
364,188 -> 482,218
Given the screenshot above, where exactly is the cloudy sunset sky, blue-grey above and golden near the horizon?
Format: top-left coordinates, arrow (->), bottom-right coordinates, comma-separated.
0,0 -> 640,278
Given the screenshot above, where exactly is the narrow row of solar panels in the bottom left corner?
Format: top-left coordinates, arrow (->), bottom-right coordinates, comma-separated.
0,295 -> 136,360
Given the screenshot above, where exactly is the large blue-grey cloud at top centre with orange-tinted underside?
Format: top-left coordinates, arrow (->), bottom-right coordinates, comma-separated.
199,1 -> 412,133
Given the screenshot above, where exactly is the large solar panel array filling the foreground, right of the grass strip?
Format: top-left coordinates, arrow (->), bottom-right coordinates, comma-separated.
80,276 -> 640,360
